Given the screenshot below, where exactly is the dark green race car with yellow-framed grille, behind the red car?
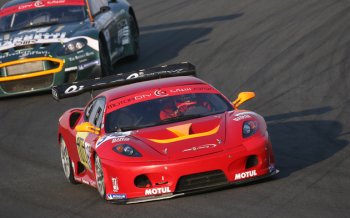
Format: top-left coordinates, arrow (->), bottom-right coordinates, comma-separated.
0,0 -> 139,97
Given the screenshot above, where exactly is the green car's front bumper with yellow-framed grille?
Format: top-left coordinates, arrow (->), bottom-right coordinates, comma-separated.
0,50 -> 101,97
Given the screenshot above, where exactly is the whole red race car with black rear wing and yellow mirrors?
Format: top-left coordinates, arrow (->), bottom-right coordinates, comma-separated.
52,63 -> 278,203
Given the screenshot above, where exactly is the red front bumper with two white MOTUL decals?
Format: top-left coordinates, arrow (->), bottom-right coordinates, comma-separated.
102,136 -> 278,203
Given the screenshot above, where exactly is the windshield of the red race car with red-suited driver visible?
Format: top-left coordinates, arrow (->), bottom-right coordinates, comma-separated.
105,93 -> 233,133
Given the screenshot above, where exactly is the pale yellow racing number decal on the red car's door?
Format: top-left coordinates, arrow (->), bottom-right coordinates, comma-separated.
76,132 -> 91,170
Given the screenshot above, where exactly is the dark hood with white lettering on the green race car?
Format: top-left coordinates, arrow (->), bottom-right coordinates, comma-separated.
0,22 -> 90,59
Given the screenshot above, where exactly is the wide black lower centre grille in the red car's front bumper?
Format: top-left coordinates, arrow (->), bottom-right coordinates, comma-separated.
175,170 -> 228,193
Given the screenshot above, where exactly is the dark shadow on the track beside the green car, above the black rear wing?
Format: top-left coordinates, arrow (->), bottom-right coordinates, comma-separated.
114,13 -> 243,73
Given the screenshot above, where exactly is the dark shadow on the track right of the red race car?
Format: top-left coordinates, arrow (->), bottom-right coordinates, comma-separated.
265,107 -> 349,178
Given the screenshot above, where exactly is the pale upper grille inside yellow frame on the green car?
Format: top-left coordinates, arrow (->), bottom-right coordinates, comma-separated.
6,61 -> 45,76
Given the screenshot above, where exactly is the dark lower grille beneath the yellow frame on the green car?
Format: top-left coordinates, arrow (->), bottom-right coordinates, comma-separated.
0,74 -> 53,93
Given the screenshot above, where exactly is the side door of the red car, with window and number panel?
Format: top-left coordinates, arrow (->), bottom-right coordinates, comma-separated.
76,97 -> 106,172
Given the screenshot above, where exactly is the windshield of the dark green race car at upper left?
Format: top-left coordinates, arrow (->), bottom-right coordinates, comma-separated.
0,6 -> 86,32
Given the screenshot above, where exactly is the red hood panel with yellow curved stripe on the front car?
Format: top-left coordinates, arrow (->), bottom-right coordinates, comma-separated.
133,114 -> 225,160
